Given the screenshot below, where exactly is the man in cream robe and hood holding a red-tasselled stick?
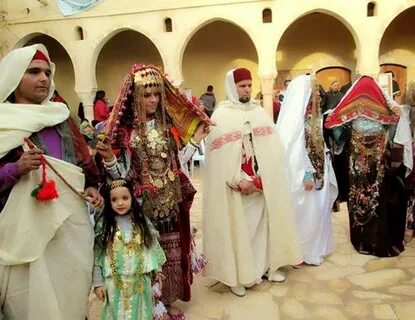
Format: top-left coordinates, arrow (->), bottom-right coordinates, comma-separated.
0,44 -> 103,320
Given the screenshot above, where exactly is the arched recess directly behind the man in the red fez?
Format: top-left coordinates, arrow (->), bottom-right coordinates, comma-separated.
182,21 -> 260,101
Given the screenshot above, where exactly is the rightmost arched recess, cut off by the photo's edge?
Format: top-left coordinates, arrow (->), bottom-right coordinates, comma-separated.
379,7 -> 415,103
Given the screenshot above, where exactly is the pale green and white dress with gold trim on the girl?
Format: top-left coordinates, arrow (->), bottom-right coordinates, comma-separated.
94,217 -> 166,320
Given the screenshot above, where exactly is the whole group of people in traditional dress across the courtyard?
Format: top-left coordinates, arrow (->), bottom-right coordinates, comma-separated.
0,44 -> 415,320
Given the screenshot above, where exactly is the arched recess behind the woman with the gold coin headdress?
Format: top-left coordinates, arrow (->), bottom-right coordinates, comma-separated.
95,30 -> 163,105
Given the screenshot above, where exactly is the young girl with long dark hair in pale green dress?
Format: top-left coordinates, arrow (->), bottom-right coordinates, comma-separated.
93,180 -> 166,320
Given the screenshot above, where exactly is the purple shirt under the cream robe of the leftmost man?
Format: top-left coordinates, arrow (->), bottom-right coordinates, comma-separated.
0,127 -> 62,192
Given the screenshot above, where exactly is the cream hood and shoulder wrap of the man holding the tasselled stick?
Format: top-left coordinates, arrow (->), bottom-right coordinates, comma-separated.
0,44 -> 69,159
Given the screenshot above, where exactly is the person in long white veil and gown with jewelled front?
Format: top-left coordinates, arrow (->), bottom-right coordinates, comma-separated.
276,75 -> 337,265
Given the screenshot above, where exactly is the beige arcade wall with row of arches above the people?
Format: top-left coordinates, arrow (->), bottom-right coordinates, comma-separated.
0,0 -> 415,112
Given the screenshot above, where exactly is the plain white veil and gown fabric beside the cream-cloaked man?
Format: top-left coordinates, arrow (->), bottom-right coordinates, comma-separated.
277,75 -> 337,265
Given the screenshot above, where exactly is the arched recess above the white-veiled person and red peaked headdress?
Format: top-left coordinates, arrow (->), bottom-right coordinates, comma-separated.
276,12 -> 356,90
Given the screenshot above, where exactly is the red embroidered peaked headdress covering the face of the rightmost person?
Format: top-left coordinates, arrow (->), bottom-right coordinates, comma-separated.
325,76 -> 398,129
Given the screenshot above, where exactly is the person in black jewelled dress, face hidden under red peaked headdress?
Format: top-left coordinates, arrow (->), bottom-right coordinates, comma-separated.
325,76 -> 412,257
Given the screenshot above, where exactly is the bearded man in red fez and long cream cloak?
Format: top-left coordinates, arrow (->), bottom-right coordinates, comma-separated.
203,68 -> 301,296
